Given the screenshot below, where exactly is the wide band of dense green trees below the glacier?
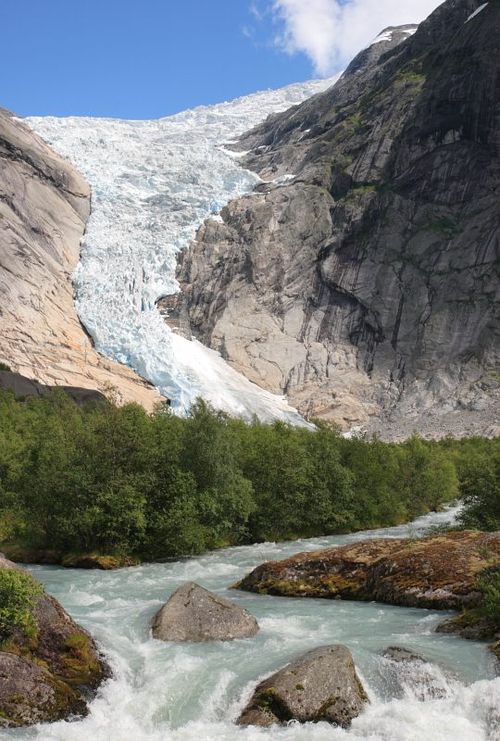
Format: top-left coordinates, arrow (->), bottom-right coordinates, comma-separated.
0,392 -> 494,559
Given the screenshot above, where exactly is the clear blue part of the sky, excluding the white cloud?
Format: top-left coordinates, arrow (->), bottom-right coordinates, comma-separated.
0,0 -> 312,118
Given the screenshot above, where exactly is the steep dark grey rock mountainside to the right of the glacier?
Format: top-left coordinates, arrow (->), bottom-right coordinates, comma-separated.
173,0 -> 500,438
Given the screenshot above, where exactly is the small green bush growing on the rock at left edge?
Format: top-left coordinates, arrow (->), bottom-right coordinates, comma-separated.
0,568 -> 42,641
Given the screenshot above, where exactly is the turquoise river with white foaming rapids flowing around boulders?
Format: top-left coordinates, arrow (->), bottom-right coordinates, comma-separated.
5,510 -> 500,741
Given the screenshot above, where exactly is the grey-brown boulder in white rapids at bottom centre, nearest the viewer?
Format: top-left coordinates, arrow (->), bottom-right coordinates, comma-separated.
238,645 -> 368,728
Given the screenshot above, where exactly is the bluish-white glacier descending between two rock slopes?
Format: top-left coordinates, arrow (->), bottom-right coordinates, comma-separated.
23,78 -> 337,424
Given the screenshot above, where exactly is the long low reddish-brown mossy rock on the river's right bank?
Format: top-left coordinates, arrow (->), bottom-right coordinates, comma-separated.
236,531 -> 500,610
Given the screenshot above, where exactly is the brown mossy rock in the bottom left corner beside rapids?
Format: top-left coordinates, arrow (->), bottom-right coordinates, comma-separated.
0,554 -> 109,726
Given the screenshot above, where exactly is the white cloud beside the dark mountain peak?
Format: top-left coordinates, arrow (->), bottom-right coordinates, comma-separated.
272,0 -> 442,75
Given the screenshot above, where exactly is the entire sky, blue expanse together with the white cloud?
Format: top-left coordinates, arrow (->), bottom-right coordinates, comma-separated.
0,0 -> 439,118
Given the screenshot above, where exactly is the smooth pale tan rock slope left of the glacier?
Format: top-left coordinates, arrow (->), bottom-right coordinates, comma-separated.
0,109 -> 160,408
